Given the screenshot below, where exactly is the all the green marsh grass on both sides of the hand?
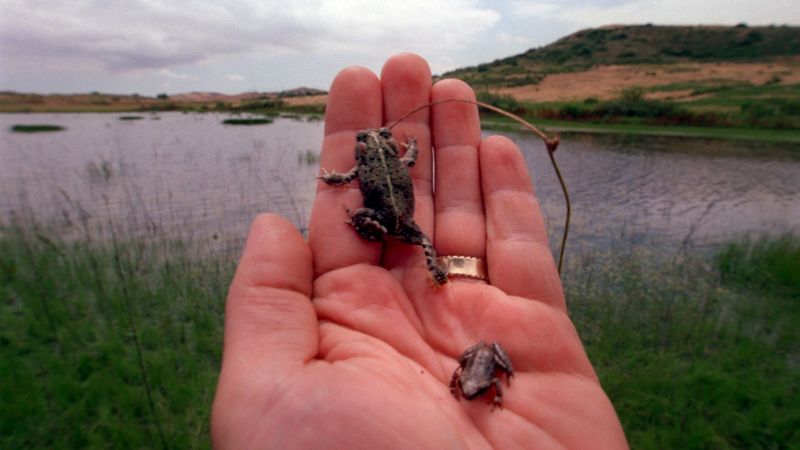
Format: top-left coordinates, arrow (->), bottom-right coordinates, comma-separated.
0,226 -> 800,449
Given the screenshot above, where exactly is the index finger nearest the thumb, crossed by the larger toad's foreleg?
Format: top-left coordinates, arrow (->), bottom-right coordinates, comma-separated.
309,67 -> 383,275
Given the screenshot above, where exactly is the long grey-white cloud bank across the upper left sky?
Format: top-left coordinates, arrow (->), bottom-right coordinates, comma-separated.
0,0 -> 500,76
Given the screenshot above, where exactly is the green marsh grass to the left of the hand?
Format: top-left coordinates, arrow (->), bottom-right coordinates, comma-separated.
0,229 -> 233,449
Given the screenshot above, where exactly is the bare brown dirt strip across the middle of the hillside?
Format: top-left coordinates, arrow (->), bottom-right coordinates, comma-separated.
497,60 -> 800,102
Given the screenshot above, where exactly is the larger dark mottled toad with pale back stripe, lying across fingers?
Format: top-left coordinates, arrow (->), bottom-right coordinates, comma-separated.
320,127 -> 447,285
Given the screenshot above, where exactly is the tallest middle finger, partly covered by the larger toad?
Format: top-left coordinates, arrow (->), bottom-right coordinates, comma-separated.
381,53 -> 433,274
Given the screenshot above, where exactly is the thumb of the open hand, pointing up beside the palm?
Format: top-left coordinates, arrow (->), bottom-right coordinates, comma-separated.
223,214 -> 318,376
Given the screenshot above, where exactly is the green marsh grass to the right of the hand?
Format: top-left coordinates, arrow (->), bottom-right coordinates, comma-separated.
567,237 -> 800,449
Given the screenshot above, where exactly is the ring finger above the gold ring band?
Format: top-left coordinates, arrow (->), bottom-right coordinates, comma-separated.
431,80 -> 486,257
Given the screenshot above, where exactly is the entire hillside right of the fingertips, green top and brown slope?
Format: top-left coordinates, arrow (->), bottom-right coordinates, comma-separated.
441,24 -> 800,130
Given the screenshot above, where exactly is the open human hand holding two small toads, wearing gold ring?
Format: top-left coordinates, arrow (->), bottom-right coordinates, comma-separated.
212,54 -> 627,449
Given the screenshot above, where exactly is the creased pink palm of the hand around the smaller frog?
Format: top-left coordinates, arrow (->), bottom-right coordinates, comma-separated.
301,267 -> 608,448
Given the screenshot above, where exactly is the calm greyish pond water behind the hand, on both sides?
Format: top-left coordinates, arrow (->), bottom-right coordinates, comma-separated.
0,113 -> 800,260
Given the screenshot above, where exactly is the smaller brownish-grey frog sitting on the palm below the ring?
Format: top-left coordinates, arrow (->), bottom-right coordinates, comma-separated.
450,341 -> 514,408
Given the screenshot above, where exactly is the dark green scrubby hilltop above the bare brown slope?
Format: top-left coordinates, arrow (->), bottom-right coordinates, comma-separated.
442,24 -> 800,86
